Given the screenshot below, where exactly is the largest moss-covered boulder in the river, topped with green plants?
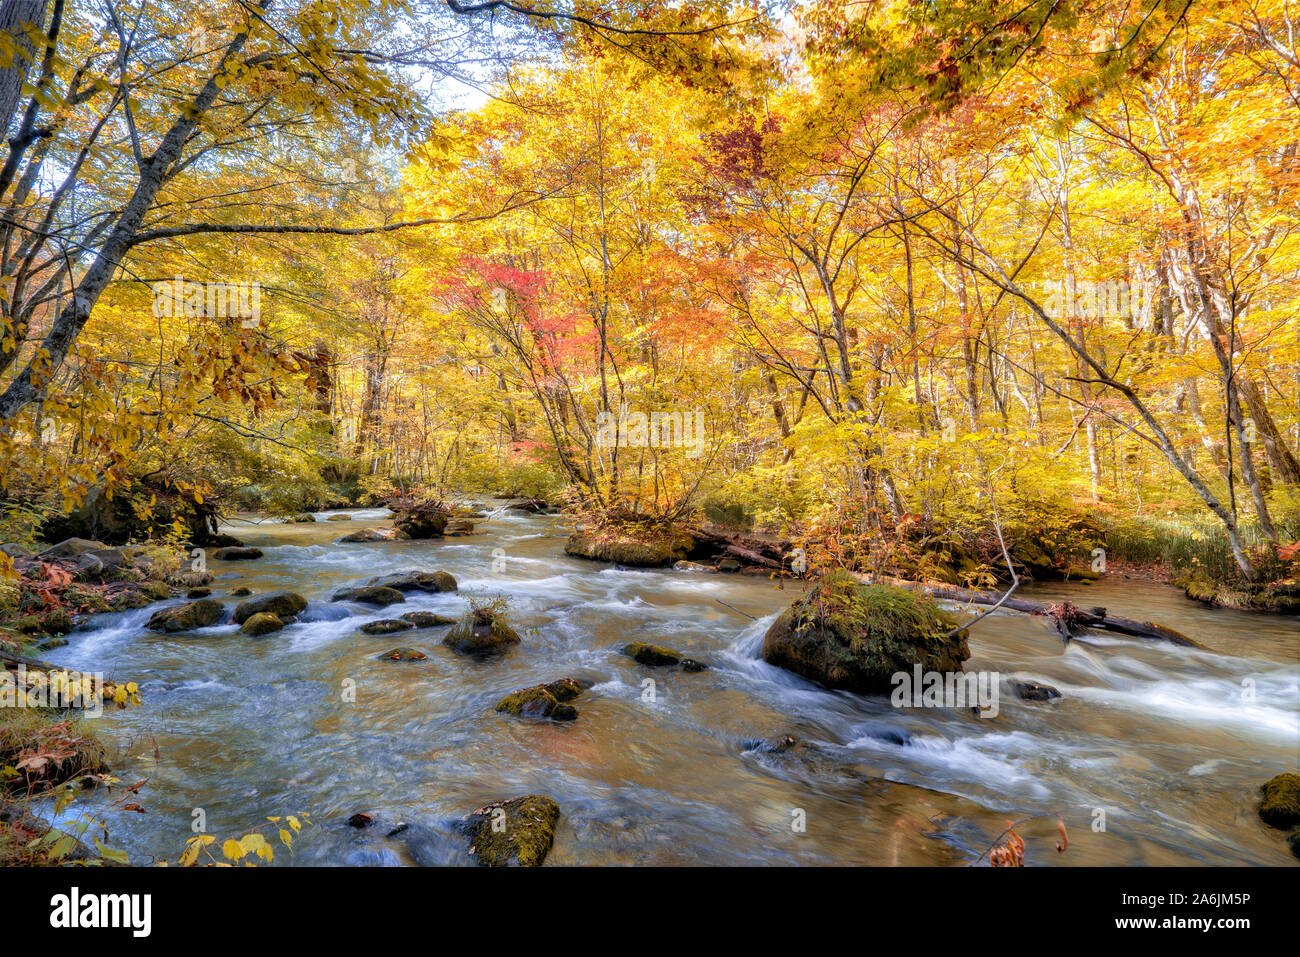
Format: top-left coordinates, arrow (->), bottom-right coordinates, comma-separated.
763,572 -> 970,694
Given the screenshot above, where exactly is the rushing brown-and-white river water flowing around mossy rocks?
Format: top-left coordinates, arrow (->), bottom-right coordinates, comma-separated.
35,511 -> 1300,865
